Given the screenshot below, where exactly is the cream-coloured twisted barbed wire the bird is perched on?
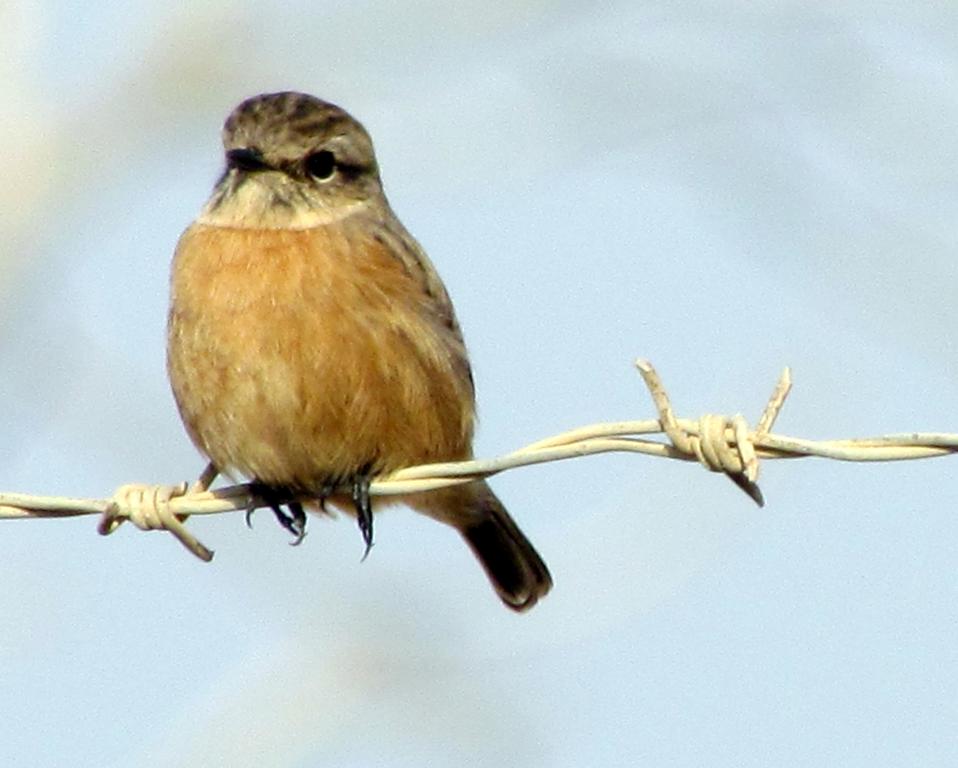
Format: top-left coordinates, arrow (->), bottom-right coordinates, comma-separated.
0,360 -> 958,562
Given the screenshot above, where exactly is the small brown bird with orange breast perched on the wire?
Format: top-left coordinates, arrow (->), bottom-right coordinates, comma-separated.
167,92 -> 552,611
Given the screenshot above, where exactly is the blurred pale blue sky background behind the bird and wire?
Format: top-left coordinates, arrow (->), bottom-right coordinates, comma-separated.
0,0 -> 958,768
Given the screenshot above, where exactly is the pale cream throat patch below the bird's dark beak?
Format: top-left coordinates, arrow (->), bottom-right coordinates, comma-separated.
196,181 -> 368,229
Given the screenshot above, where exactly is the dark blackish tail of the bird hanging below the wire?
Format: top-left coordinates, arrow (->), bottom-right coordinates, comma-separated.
459,487 -> 552,611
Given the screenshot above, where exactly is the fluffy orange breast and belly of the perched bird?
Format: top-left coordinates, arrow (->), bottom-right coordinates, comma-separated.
168,222 -> 474,490
